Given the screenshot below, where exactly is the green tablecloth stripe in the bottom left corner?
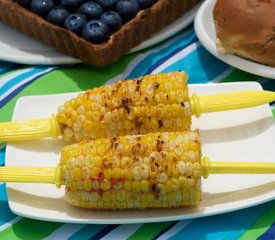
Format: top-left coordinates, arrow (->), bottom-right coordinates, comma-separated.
0,218 -> 63,240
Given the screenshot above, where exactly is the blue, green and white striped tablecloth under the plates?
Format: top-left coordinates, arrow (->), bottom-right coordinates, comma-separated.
0,23 -> 275,240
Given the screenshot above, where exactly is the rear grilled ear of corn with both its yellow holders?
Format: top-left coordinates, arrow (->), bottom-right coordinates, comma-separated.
0,72 -> 275,142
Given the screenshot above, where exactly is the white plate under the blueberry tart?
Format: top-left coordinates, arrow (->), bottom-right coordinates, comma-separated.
0,4 -> 203,65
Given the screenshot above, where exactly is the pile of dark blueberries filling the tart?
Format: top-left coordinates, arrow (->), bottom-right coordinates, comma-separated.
15,0 -> 157,44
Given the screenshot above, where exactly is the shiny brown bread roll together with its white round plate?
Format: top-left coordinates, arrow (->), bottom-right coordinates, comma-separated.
194,0 -> 275,78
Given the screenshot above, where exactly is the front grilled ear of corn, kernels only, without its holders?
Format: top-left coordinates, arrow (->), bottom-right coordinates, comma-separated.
60,131 -> 202,209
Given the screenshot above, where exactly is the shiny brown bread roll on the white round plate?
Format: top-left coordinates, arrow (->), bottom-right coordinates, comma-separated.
213,0 -> 275,67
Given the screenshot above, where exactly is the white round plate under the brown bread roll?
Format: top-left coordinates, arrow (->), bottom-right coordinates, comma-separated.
194,0 -> 275,78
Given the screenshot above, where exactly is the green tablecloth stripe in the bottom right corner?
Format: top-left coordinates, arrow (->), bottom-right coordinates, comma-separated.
240,204 -> 275,240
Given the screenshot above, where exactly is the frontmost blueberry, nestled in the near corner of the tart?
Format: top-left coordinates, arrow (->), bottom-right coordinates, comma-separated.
82,20 -> 109,44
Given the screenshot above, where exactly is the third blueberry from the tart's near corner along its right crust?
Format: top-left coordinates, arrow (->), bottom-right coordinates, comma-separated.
116,0 -> 139,22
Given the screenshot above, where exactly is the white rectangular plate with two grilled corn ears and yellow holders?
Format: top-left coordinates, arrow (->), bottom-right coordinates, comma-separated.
0,71 -> 275,224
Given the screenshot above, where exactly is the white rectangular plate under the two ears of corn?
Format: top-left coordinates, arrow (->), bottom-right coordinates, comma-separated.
6,82 -> 275,224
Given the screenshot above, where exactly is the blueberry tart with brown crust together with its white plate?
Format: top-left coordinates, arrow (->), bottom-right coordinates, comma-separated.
0,0 -> 200,66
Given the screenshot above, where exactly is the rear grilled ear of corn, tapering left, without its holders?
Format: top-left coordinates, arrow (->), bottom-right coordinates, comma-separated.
56,72 -> 191,142
